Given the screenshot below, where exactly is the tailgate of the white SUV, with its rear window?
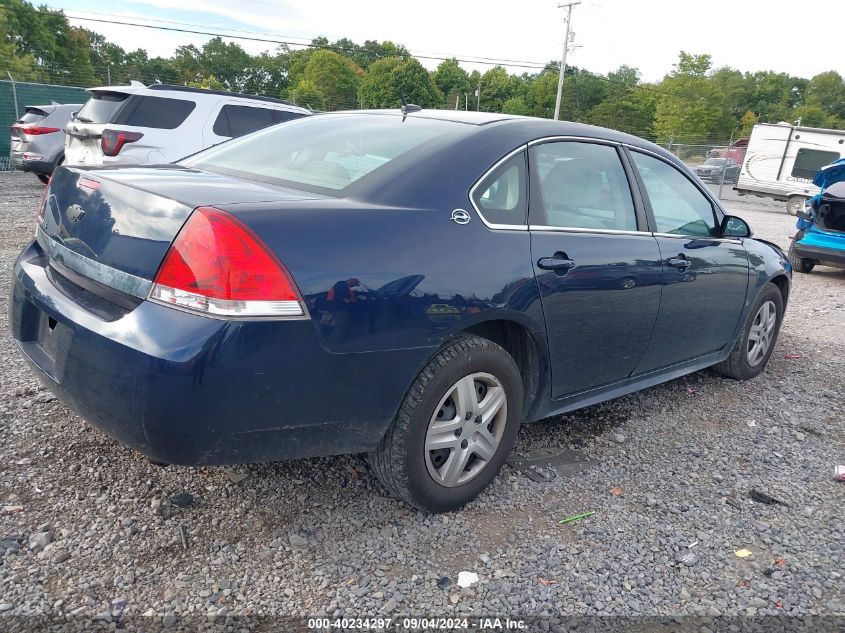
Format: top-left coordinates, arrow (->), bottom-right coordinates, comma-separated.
65,90 -> 129,165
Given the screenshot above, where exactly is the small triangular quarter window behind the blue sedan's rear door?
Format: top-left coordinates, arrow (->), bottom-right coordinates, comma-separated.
473,152 -> 528,225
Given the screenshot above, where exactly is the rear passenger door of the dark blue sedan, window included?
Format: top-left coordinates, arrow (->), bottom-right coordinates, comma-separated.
529,140 -> 662,398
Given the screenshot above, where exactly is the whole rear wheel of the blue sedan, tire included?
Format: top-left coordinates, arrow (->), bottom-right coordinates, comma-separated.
369,334 -> 523,512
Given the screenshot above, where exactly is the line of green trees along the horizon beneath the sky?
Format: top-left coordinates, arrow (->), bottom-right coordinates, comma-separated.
0,0 -> 845,144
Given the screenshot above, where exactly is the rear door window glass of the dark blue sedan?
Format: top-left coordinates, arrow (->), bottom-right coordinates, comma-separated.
531,141 -> 637,231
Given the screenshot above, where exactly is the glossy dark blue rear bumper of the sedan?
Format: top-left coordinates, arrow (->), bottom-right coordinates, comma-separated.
10,243 -> 420,465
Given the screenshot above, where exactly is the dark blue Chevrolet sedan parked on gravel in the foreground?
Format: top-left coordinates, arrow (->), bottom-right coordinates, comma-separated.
11,111 -> 791,511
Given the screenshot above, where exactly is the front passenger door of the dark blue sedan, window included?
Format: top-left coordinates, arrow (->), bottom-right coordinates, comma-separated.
630,150 -> 748,373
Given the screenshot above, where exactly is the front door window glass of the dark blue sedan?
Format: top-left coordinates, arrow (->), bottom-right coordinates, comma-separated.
631,152 -> 719,237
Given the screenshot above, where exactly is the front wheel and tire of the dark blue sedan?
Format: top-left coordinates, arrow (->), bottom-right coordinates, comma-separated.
713,283 -> 783,380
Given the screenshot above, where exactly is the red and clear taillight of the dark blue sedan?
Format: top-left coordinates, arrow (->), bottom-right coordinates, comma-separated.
150,207 -> 305,317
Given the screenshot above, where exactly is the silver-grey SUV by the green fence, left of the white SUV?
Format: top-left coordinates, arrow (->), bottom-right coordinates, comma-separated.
9,103 -> 82,183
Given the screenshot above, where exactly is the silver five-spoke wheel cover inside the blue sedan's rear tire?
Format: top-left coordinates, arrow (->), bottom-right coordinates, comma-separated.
424,373 -> 508,488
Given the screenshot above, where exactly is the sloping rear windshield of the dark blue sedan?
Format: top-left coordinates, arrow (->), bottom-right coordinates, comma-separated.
182,114 -> 466,193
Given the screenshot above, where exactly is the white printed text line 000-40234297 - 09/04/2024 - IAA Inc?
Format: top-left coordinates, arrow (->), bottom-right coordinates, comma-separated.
308,617 -> 527,631
